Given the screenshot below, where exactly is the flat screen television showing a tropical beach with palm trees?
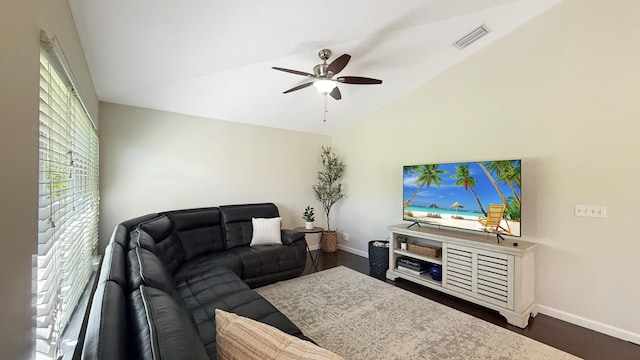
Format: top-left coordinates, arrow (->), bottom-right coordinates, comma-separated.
402,160 -> 522,237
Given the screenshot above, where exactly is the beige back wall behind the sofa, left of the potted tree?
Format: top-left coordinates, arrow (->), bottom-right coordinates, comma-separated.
100,103 -> 331,247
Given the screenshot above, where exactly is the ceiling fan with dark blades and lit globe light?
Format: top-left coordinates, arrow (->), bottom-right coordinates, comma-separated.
272,49 -> 382,100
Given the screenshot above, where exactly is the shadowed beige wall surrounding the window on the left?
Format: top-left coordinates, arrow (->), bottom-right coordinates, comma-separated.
0,0 -> 98,359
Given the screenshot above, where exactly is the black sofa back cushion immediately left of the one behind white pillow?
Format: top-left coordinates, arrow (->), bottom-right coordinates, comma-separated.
168,208 -> 224,260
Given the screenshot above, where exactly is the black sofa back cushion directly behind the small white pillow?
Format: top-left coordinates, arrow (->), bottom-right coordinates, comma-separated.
220,203 -> 280,249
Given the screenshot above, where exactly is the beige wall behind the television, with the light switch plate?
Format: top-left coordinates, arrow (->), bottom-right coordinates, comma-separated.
334,0 -> 640,342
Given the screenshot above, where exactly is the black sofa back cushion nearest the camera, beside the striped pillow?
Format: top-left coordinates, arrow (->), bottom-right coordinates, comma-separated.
130,286 -> 209,360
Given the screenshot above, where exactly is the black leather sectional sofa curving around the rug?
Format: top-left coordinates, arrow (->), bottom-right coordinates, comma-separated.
82,203 -> 310,360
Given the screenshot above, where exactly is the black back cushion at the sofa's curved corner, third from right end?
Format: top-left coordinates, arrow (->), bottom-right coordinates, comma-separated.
140,215 -> 185,274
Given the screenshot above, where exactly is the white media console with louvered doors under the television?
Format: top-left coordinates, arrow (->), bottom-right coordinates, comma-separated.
387,224 -> 537,328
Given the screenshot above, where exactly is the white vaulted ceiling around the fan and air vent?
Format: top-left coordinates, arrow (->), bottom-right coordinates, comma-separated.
69,0 -> 560,134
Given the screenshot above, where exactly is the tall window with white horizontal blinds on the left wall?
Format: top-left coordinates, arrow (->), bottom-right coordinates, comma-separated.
34,35 -> 99,359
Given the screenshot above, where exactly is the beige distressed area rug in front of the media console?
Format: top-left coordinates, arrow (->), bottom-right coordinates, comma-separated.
257,266 -> 578,360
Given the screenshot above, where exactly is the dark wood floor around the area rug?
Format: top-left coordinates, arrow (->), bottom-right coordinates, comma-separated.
304,250 -> 640,360
